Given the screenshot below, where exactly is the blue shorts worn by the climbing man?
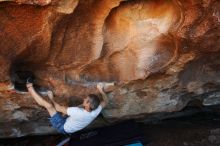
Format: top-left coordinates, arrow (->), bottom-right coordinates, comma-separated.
50,112 -> 67,134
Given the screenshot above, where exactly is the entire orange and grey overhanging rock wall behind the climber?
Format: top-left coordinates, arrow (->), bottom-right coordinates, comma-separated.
0,0 -> 220,137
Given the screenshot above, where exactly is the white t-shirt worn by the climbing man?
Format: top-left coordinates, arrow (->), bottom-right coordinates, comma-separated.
64,105 -> 102,133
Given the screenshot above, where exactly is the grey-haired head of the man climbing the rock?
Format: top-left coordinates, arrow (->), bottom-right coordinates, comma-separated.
83,94 -> 100,111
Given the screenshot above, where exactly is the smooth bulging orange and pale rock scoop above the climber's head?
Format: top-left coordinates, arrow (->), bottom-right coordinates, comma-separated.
80,1 -> 180,82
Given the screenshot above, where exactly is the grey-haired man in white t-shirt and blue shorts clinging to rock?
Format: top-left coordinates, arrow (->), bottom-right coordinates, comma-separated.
26,82 -> 108,134
